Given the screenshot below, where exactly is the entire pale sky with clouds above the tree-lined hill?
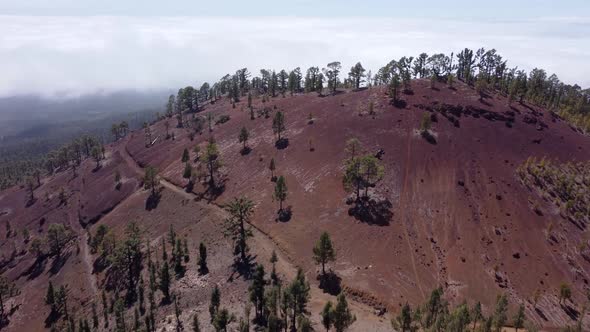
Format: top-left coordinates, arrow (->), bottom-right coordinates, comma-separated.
0,0 -> 590,97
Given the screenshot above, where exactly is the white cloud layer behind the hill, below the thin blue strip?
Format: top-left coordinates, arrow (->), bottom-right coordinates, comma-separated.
0,16 -> 590,96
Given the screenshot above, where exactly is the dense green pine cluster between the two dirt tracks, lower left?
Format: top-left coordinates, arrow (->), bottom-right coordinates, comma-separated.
45,222 -> 208,332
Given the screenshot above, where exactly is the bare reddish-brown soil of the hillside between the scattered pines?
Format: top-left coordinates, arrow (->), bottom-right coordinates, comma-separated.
0,80 -> 590,331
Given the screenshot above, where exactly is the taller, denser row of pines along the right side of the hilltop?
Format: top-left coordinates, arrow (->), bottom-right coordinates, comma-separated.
373,48 -> 590,133
